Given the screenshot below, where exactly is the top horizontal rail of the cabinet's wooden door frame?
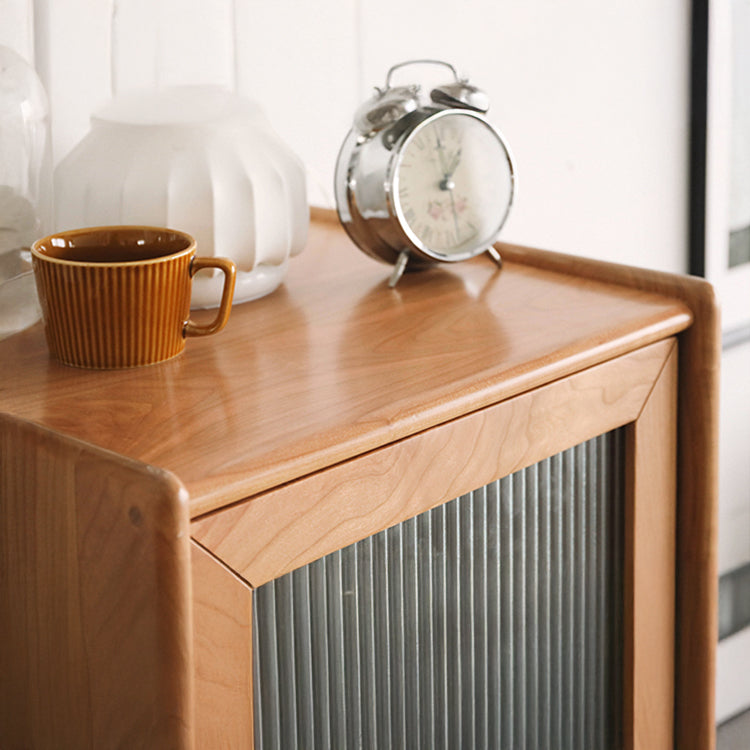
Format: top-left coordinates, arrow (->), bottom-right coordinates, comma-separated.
191,339 -> 675,587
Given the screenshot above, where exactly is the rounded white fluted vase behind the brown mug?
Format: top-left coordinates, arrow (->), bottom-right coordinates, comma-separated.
55,86 -> 309,307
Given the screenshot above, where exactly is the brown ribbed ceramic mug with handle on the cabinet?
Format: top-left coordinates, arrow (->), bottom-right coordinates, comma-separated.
31,226 -> 235,369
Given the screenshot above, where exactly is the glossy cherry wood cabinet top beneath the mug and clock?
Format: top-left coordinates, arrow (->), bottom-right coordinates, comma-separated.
0,214 -> 693,516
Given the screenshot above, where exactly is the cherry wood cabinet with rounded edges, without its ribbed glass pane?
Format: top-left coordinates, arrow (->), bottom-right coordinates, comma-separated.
0,212 -> 719,750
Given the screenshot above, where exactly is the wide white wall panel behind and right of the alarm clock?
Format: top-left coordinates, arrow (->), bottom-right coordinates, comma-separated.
363,0 -> 689,270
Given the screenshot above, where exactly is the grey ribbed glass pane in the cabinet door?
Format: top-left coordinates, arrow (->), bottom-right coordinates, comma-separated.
254,430 -> 624,750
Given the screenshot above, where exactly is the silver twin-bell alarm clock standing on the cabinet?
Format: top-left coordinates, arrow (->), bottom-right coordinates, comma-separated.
334,60 -> 516,287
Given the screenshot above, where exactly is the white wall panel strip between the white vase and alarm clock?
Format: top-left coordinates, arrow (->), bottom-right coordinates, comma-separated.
236,0 -> 362,205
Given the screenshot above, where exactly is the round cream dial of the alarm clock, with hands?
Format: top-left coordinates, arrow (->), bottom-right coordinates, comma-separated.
392,110 -> 513,260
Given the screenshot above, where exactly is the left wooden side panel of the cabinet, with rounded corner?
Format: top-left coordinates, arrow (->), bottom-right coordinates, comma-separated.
0,415 -> 192,750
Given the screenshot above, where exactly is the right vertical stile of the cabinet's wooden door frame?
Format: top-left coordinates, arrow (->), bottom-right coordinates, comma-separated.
623,349 -> 677,750
